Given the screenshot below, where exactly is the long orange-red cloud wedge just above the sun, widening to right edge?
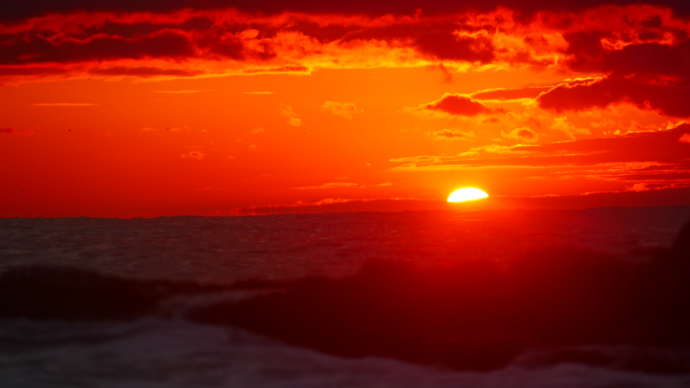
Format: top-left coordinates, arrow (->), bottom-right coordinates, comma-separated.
391,124 -> 690,188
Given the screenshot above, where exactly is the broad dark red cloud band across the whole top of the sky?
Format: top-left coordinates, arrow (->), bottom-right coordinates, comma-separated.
0,0 -> 690,88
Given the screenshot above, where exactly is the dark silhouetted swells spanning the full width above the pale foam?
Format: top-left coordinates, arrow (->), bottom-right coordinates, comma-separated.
0,218 -> 690,373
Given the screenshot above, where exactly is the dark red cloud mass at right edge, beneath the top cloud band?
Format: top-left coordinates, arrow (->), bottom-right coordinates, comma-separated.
539,24 -> 690,117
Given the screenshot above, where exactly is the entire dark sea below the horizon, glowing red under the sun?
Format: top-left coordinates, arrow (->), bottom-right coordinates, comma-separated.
0,208 -> 690,387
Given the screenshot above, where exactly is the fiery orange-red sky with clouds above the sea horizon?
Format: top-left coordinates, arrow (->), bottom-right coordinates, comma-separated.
0,0 -> 690,217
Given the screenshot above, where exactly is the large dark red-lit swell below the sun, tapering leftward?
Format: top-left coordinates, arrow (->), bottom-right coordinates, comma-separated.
189,218 -> 690,373
